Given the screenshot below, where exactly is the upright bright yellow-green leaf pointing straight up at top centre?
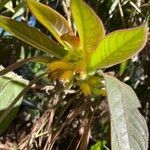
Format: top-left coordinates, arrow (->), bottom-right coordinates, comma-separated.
71,0 -> 105,51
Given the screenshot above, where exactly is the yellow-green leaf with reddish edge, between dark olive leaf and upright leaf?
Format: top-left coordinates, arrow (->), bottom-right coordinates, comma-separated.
27,0 -> 72,45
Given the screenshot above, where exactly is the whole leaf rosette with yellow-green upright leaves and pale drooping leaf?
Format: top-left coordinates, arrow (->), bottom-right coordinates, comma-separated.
0,0 -> 148,150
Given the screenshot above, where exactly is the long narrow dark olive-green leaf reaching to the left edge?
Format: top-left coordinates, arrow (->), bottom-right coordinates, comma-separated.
0,16 -> 66,58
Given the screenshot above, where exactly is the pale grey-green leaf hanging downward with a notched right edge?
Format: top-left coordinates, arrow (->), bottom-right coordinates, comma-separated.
104,74 -> 148,150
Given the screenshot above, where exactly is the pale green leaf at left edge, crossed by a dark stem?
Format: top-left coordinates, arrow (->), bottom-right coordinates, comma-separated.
0,66 -> 28,134
